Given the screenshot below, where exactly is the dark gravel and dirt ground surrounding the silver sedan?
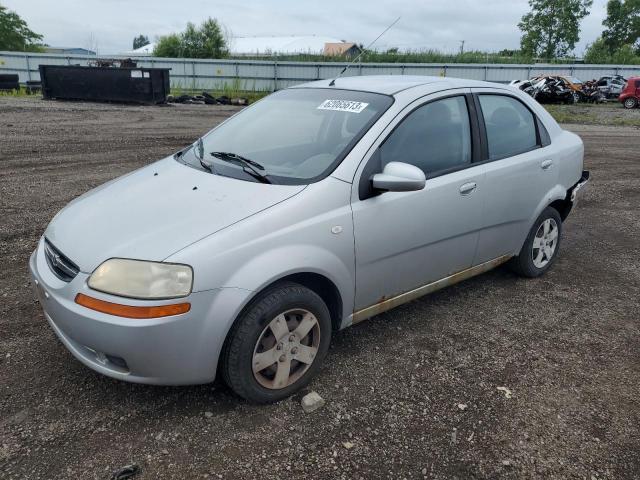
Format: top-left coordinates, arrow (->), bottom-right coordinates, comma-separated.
0,97 -> 640,480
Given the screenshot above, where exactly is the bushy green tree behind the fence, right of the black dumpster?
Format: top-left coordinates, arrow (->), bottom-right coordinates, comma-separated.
153,18 -> 229,58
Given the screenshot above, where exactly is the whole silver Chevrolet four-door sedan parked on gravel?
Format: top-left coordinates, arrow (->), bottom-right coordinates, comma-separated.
30,75 -> 588,402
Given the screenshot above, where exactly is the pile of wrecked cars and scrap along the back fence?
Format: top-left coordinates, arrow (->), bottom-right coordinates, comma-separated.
509,75 -> 626,104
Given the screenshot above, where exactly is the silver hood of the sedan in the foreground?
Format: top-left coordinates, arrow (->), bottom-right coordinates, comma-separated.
45,157 -> 304,273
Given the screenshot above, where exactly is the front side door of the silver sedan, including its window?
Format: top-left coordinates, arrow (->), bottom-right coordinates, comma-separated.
352,91 -> 484,321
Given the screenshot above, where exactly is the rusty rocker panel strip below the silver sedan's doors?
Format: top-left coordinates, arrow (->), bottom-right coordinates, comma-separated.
351,255 -> 513,325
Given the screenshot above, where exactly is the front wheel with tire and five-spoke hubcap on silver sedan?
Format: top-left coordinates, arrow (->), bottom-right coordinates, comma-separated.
221,282 -> 332,403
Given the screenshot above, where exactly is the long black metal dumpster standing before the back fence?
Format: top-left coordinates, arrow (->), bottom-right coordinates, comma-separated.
40,65 -> 170,104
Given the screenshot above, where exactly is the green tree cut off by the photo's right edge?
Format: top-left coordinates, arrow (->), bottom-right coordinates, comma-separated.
602,0 -> 640,53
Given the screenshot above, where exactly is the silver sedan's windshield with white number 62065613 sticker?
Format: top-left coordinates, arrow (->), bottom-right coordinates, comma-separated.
181,88 -> 393,184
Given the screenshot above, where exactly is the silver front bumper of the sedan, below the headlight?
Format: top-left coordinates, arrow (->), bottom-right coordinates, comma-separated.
29,240 -> 250,385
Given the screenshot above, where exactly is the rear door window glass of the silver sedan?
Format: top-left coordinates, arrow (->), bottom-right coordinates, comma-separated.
480,95 -> 538,160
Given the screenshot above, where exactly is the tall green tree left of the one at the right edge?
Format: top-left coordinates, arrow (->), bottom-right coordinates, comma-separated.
518,0 -> 593,59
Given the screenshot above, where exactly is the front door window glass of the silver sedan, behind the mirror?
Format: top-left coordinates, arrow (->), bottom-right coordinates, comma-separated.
380,96 -> 471,176
